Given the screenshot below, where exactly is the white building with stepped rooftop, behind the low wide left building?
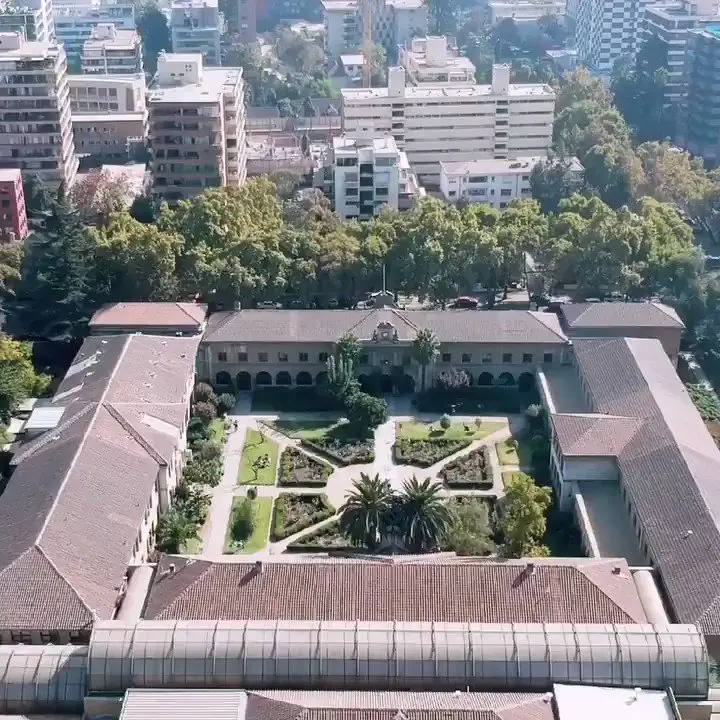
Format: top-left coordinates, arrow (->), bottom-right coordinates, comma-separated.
80,25 -> 143,75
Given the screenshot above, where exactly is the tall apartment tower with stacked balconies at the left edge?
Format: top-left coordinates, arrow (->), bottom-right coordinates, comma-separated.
0,33 -> 78,187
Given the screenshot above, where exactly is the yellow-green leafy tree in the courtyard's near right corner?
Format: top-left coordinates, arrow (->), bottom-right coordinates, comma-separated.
498,473 -> 552,557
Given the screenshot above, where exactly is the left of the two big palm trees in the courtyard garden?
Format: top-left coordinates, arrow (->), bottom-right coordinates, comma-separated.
340,473 -> 393,552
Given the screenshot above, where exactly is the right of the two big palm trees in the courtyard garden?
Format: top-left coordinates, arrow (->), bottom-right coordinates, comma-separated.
400,475 -> 452,553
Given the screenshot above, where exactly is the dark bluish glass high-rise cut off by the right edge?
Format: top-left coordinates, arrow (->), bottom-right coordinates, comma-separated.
677,25 -> 720,164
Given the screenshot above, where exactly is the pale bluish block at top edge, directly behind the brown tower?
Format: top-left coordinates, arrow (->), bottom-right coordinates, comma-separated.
170,0 -> 225,65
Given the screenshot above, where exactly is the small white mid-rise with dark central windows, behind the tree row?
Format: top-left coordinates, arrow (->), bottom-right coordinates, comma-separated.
316,135 -> 425,220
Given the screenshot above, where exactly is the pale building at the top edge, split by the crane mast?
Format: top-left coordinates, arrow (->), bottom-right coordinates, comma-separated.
322,0 -> 428,57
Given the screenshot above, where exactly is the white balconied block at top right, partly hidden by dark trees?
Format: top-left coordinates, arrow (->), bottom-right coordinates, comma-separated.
641,0 -> 720,104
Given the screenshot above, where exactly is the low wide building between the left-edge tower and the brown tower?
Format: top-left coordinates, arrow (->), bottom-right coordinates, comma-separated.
68,73 -> 148,161
